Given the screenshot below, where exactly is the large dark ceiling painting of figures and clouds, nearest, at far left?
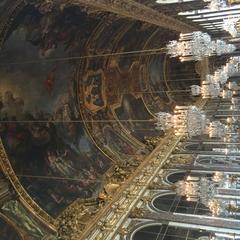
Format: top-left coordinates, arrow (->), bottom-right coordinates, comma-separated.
0,4 -> 113,216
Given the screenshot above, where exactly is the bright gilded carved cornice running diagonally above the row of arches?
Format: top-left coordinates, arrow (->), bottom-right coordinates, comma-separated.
79,132 -> 180,240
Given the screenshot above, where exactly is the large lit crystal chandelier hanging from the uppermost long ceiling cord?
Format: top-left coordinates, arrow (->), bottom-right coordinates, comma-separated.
166,31 -> 236,62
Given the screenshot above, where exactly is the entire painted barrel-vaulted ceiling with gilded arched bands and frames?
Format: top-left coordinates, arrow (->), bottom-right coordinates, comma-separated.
0,0 -> 201,237
